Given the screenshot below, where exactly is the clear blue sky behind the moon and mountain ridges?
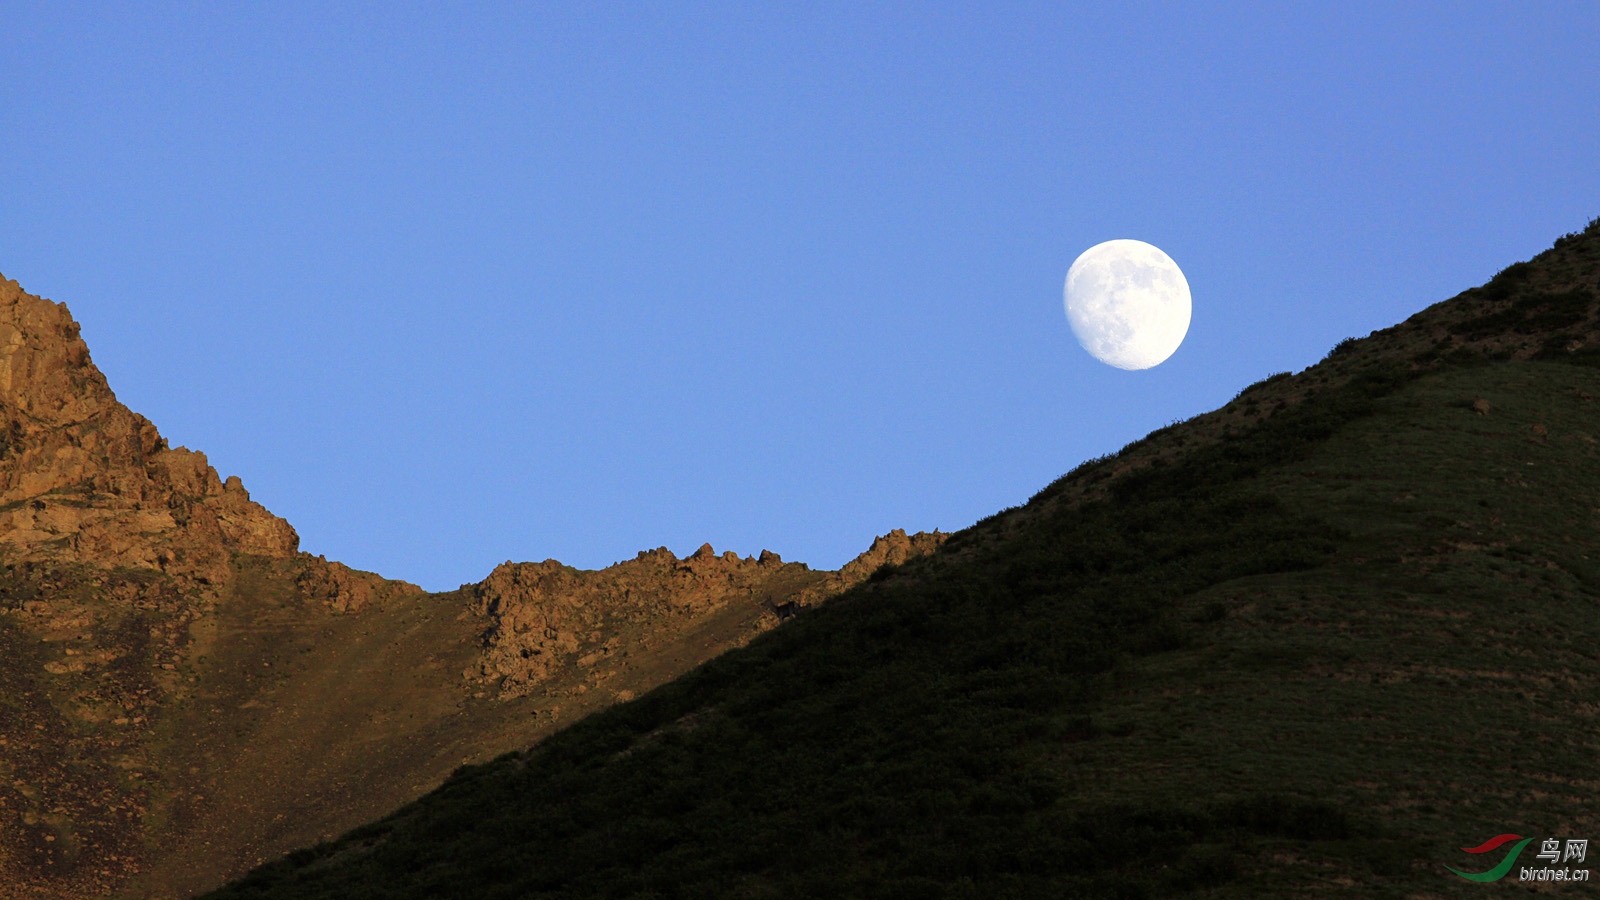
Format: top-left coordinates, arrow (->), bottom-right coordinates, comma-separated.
0,0 -> 1600,589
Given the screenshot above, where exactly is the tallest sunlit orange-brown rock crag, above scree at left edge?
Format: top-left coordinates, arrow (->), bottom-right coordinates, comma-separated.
0,277 -> 299,585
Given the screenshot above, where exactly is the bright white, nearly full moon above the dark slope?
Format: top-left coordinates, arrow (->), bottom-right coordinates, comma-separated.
1066,240 -> 1192,368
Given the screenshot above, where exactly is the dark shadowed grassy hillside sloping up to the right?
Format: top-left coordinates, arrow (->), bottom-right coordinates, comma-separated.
210,224 -> 1600,898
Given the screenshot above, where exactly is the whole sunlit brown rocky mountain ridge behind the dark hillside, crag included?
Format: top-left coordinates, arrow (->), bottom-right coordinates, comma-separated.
0,279 -> 944,898
